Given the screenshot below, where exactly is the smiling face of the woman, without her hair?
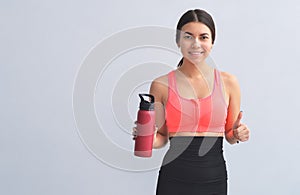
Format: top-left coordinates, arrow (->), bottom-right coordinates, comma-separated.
178,22 -> 213,64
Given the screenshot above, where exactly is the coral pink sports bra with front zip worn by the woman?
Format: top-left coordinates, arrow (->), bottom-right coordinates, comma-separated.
165,69 -> 227,133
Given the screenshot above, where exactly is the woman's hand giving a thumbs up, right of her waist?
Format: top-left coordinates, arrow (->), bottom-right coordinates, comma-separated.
232,111 -> 250,142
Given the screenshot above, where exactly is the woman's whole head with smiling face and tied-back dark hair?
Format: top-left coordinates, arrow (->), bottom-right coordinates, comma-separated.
176,9 -> 216,66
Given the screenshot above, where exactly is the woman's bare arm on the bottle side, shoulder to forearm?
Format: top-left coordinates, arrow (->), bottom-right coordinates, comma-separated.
150,76 -> 169,148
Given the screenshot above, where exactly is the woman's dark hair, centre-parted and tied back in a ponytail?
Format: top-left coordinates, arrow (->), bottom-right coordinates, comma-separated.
176,9 -> 216,67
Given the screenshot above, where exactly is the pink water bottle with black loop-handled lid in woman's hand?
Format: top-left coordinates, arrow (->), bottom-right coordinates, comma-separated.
134,94 -> 155,157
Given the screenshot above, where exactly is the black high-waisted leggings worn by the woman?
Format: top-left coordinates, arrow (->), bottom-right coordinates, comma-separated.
156,136 -> 227,195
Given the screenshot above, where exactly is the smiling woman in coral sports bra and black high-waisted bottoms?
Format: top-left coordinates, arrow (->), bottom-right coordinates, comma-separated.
134,9 -> 249,195
